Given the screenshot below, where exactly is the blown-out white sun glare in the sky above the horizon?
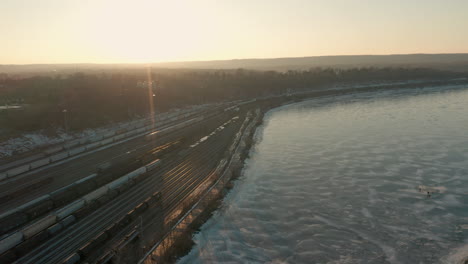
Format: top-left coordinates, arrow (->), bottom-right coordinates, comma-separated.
83,1 -> 209,62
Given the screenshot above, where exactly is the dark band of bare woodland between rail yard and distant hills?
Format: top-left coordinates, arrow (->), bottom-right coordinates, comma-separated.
0,68 -> 460,131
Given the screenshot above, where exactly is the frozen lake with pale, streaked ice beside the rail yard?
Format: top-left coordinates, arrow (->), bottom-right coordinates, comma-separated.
179,87 -> 468,264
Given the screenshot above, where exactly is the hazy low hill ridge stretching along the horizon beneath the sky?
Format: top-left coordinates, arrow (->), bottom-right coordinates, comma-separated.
0,53 -> 468,75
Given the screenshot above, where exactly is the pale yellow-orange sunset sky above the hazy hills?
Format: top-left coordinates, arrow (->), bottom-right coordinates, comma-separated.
0,0 -> 468,64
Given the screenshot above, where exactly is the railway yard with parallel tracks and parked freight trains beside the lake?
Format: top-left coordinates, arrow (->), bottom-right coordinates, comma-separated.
0,99 -> 264,263
